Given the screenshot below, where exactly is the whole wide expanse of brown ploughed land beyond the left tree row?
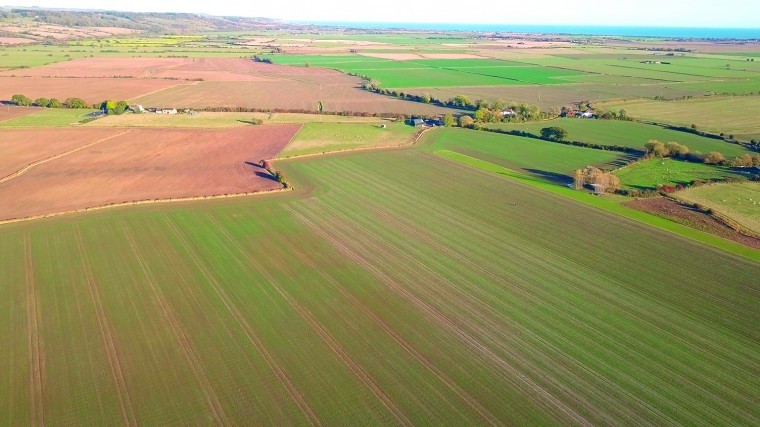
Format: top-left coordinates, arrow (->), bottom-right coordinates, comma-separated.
0,58 -> 458,115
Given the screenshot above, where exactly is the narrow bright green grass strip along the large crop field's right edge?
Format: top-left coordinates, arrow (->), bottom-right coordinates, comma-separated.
434,150 -> 760,262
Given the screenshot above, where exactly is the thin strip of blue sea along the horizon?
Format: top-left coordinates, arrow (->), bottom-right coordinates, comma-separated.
298,21 -> 760,40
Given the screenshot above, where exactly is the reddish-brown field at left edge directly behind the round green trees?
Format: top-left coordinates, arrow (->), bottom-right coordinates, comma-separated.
0,77 -> 188,103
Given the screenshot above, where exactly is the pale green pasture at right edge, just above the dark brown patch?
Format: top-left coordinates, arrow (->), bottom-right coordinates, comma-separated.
676,182 -> 760,235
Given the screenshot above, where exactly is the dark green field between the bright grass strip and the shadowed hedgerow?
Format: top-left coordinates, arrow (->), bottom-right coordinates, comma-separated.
421,129 -> 626,183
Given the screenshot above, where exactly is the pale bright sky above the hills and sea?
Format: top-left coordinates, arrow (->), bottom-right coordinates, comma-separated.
6,0 -> 760,28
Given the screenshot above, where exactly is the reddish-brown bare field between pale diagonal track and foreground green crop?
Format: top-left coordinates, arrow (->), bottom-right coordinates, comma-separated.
0,125 -> 299,220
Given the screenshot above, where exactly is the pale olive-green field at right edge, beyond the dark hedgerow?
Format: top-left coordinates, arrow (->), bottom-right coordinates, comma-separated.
603,96 -> 760,141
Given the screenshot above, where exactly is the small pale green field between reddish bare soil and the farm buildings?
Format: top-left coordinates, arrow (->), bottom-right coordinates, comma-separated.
280,123 -> 419,157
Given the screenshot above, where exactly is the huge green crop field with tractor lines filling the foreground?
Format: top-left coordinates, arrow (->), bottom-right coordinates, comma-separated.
0,142 -> 760,425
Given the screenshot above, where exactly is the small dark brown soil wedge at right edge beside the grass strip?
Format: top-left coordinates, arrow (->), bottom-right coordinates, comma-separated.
626,197 -> 760,249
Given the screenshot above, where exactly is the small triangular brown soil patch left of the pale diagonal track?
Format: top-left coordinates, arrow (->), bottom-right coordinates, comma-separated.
0,128 -> 123,180
